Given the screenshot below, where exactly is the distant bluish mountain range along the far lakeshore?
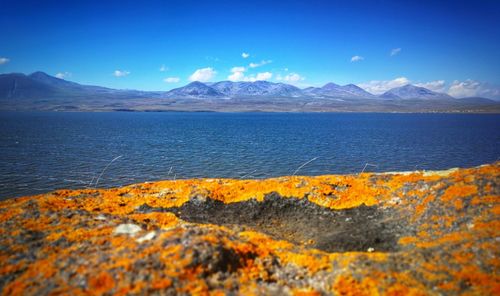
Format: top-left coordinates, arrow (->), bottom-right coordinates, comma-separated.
0,72 -> 500,113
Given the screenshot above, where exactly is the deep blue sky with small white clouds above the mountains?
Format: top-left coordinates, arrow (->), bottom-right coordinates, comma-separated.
0,0 -> 500,97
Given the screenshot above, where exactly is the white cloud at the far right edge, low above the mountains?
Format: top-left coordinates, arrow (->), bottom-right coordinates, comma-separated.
448,79 -> 500,99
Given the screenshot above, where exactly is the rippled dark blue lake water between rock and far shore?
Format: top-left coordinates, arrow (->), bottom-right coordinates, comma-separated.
0,112 -> 500,199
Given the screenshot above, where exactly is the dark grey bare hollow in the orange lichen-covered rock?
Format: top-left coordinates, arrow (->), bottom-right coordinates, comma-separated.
137,192 -> 413,252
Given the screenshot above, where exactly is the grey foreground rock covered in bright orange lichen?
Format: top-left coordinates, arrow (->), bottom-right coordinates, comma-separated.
0,162 -> 500,295
